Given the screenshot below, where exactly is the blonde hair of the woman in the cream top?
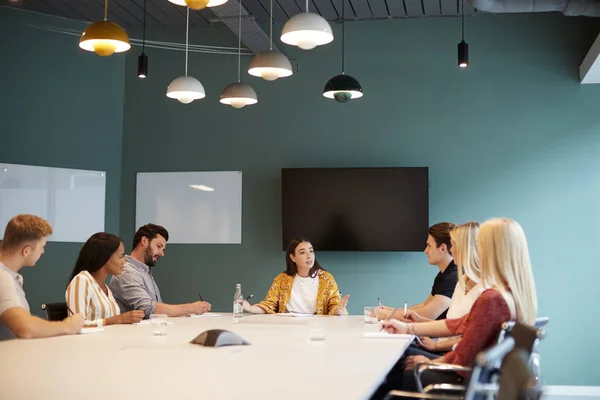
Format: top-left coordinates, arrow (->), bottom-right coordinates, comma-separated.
450,221 -> 481,289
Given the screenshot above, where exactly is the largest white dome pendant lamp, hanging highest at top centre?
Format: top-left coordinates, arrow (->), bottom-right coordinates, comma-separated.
281,0 -> 333,50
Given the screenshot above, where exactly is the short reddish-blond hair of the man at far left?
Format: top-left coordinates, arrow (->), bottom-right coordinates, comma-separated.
0,214 -> 52,251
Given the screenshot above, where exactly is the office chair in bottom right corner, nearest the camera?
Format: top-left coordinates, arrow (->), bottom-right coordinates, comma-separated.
386,323 -> 544,400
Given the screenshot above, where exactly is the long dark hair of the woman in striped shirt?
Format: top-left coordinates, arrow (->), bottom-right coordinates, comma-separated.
69,232 -> 121,282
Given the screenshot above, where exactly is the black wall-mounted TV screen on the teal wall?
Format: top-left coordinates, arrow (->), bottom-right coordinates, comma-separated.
281,167 -> 429,251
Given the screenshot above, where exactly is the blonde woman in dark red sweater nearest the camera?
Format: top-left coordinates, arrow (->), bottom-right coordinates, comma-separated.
382,218 -> 537,391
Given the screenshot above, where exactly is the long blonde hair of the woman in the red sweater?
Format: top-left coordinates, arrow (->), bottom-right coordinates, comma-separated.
477,218 -> 537,326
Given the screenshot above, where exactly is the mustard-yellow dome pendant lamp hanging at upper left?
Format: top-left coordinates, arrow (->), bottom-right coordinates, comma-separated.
79,0 -> 131,57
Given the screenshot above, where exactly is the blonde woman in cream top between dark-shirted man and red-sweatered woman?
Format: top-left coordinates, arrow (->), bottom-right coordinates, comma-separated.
401,221 -> 484,358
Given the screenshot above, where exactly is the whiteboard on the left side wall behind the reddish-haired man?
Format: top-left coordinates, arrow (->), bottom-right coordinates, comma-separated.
0,163 -> 106,243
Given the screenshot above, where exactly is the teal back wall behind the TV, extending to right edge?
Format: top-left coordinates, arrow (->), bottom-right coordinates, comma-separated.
121,15 -> 600,385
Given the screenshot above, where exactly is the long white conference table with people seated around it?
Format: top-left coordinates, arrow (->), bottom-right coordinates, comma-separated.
0,314 -> 411,400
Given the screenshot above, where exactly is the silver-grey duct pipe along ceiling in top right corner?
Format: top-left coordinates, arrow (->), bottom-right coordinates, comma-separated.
467,0 -> 600,17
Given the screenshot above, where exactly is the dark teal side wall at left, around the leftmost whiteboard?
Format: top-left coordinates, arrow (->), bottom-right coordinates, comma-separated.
0,7 -> 125,315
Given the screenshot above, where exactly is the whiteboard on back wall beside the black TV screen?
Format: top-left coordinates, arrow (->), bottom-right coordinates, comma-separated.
135,171 -> 242,244
